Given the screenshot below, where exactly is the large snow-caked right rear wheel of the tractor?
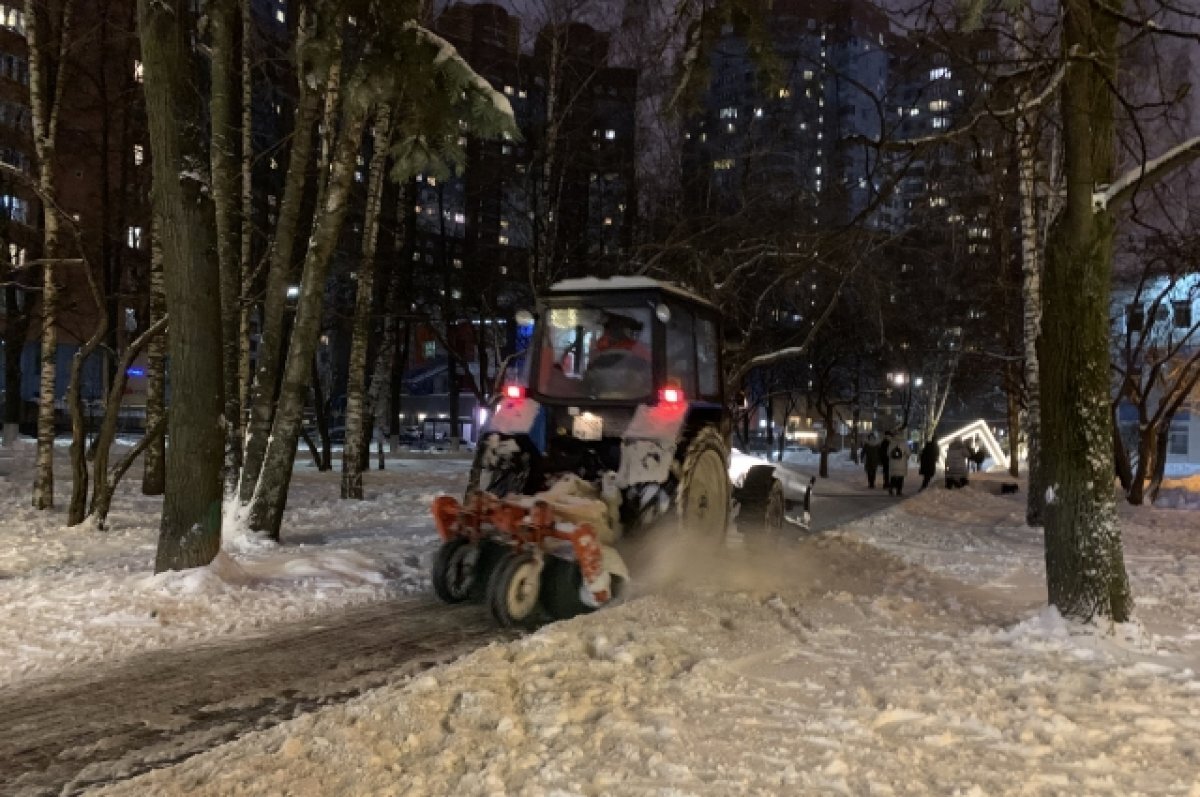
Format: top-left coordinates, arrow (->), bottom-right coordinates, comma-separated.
676,426 -> 730,544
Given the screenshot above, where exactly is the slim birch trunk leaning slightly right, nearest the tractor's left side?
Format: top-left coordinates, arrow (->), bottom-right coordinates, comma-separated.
342,104 -> 391,499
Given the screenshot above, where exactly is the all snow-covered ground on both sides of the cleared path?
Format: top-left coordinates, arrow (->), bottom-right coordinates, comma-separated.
0,439 -> 1200,797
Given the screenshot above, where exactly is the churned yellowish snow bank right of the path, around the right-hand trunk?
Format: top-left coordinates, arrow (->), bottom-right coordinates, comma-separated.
104,486 -> 1200,797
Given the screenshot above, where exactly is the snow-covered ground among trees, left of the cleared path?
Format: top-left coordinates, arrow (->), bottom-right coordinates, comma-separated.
0,447 -> 468,684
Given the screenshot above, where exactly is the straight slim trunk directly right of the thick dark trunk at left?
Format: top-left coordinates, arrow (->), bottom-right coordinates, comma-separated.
208,0 -> 245,497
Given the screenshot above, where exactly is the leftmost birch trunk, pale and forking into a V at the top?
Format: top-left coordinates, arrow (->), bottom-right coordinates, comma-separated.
25,0 -> 73,509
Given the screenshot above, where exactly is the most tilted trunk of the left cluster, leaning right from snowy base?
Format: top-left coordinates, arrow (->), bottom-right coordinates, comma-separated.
248,97 -> 367,540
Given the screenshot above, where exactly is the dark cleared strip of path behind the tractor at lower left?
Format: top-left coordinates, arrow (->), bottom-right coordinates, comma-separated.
0,597 -> 502,795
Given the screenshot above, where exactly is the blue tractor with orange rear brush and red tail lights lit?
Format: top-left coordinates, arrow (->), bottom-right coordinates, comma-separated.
432,277 -> 811,627
